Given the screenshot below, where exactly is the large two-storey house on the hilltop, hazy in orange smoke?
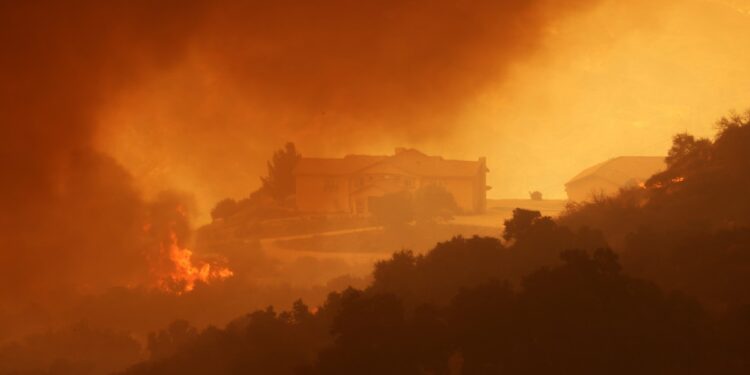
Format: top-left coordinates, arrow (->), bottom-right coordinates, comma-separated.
294,148 -> 489,214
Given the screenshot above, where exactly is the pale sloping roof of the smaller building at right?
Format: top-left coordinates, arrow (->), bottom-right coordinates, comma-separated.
565,156 -> 666,186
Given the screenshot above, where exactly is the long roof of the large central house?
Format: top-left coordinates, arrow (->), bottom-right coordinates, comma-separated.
294,149 -> 486,177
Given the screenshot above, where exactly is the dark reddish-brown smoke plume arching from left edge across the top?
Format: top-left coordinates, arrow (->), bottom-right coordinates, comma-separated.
0,0 -> 591,336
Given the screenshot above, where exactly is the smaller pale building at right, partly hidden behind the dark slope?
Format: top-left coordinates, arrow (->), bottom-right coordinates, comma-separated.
565,156 -> 666,202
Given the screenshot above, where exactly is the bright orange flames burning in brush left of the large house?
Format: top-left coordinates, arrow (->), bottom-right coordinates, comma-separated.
157,231 -> 234,294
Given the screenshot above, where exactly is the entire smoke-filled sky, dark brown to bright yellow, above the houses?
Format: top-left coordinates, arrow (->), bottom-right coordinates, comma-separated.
0,0 -> 750,326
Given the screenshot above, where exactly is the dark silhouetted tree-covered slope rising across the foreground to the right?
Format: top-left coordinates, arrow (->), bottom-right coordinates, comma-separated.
122,110 -> 750,375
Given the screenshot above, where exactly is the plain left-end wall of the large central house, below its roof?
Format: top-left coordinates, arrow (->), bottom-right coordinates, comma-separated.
295,176 -> 351,213
